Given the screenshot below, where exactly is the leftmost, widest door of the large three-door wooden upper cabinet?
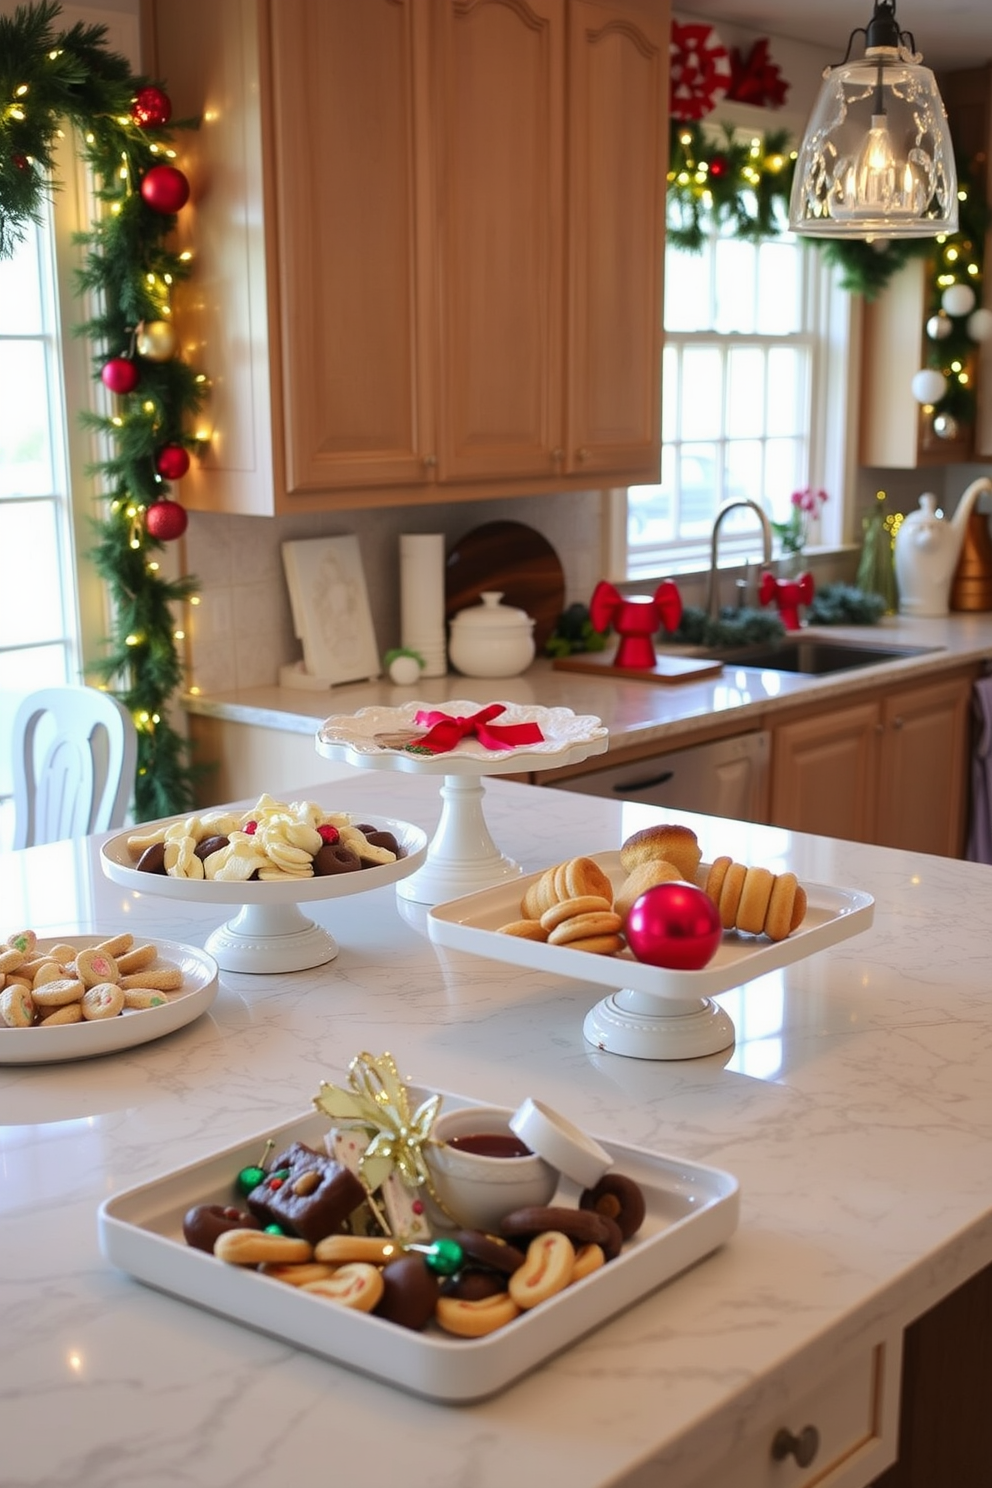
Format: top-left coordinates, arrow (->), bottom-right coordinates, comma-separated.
271,0 -> 431,491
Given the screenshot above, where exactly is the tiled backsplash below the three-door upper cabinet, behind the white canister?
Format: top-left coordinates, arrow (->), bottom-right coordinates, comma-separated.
186,491 -> 602,693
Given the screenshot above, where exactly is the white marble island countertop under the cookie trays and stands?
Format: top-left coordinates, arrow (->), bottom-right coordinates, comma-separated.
0,772 -> 992,1488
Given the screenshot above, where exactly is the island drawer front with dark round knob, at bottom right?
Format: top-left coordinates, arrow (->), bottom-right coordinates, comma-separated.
692,1333 -> 901,1488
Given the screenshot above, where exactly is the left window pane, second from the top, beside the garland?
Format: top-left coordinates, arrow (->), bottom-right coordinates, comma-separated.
0,341 -> 52,496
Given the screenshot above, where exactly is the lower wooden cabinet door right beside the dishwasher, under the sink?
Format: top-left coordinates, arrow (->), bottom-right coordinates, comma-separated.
772,702 -> 879,842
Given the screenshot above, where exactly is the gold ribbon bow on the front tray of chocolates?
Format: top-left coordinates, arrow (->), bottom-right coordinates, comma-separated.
314,1054 -> 442,1193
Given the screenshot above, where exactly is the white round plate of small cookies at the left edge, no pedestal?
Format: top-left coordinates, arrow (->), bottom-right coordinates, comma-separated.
0,930 -> 217,1064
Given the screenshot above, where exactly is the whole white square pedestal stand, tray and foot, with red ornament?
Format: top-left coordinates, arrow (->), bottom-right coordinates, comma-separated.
427,853 -> 875,1059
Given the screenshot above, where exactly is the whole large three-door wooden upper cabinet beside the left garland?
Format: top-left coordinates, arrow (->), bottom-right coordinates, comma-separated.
149,0 -> 669,513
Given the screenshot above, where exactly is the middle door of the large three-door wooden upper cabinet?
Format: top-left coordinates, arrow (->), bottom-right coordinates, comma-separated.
436,0 -> 565,481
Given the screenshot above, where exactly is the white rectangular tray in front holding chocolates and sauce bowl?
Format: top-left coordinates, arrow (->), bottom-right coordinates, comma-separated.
98,1092 -> 739,1403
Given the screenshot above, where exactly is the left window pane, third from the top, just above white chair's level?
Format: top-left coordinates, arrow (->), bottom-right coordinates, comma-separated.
0,501 -> 65,647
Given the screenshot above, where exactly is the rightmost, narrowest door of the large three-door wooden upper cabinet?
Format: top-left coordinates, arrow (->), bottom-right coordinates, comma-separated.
565,0 -> 668,473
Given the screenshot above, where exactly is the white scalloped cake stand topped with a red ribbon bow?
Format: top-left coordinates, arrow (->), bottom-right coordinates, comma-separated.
317,699 -> 610,905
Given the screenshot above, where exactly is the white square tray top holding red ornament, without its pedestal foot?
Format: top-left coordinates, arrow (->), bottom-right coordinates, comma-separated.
427,853 -> 875,1001
